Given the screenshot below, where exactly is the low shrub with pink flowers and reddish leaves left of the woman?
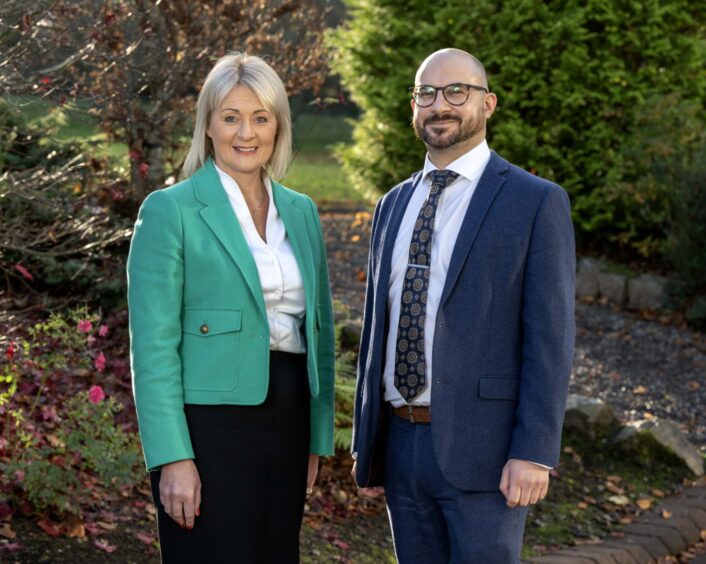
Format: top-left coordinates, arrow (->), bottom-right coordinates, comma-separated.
0,310 -> 143,516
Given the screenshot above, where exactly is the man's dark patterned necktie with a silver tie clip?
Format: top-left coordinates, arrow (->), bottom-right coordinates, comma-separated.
395,170 -> 458,403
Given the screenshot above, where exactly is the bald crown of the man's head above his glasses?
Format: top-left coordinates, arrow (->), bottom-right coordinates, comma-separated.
414,48 -> 488,88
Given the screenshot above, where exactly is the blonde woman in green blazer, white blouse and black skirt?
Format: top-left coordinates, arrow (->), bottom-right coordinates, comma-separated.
128,50 -> 334,564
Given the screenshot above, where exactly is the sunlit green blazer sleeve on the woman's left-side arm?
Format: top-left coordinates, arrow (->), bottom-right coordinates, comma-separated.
127,190 -> 194,470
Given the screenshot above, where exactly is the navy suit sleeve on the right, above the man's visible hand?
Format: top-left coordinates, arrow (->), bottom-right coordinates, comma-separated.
509,185 -> 576,467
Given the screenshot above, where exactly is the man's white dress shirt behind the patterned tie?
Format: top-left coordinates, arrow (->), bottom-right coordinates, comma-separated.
383,140 -> 490,407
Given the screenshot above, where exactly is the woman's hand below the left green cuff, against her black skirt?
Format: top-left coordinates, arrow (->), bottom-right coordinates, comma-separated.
159,459 -> 201,529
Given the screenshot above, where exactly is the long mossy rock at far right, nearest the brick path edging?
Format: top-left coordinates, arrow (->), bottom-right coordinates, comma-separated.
615,418 -> 704,476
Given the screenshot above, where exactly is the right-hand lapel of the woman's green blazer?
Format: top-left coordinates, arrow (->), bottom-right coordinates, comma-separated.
271,180 -> 316,322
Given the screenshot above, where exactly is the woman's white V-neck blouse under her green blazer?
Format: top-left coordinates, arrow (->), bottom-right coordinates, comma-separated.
216,167 -> 306,353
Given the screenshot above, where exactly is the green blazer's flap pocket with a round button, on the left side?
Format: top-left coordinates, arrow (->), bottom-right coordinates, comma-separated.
181,308 -> 242,392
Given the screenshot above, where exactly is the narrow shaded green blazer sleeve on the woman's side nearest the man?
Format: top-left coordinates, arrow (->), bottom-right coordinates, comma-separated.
309,199 -> 336,456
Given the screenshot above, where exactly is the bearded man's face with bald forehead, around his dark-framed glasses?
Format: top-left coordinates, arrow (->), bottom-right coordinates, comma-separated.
412,56 -> 494,149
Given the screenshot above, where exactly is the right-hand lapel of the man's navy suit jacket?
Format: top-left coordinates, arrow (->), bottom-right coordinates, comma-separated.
439,152 -> 508,307
